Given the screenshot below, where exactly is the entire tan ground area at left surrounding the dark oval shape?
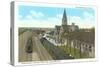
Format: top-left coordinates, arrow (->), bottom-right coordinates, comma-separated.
19,31 -> 53,62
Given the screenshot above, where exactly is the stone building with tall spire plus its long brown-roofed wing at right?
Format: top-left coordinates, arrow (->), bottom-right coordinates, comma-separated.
54,10 -> 95,57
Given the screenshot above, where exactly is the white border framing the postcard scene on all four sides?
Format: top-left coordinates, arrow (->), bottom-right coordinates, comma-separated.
14,1 -> 98,66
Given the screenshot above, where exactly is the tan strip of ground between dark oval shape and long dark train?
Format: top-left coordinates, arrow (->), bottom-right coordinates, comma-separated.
33,37 -> 52,60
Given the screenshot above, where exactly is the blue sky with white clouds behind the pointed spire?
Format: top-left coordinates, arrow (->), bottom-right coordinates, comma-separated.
18,5 -> 95,28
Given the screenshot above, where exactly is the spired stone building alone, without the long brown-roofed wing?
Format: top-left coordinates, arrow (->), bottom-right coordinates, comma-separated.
54,9 -> 79,43
